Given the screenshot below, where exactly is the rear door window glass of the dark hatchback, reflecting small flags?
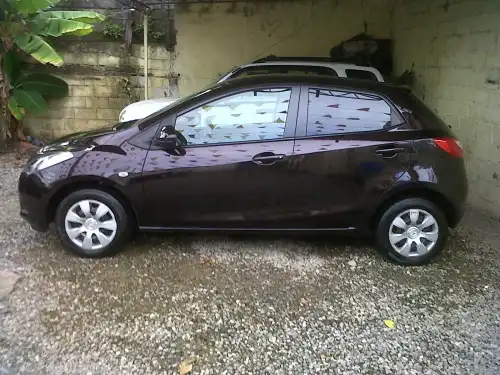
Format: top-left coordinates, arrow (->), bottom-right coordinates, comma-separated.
307,89 -> 392,136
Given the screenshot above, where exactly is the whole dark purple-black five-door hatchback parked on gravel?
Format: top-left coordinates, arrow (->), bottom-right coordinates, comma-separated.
19,75 -> 467,265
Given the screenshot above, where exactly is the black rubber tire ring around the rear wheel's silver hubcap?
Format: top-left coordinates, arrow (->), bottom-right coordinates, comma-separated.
376,198 -> 449,266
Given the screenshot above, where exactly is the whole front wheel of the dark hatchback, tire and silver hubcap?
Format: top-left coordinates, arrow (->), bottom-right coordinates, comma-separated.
56,189 -> 130,258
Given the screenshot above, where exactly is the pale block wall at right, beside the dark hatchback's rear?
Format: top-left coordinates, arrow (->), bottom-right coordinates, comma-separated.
394,0 -> 500,216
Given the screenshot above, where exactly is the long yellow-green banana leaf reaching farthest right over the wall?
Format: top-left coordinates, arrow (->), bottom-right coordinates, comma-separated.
28,18 -> 94,37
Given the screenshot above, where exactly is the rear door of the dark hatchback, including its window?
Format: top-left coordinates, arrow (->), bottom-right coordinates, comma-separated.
292,86 -> 413,229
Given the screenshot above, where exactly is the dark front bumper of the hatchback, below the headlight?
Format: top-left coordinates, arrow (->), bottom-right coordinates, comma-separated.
18,172 -> 49,232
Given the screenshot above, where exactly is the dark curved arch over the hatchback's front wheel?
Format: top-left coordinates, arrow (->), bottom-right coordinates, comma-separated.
47,176 -> 138,225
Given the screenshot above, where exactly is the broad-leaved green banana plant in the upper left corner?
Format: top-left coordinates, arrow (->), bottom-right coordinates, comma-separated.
0,0 -> 104,137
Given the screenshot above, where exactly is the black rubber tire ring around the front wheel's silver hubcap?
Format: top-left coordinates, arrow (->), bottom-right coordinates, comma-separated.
55,189 -> 132,258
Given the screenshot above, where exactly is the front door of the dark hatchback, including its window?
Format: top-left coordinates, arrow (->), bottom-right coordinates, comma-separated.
139,87 -> 300,229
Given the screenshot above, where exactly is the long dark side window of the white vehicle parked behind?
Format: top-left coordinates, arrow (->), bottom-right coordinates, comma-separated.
231,65 -> 338,78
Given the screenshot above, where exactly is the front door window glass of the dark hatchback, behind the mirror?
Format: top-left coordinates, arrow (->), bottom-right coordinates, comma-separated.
175,88 -> 292,145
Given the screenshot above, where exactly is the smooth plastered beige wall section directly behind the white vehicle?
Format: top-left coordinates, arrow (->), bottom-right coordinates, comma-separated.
175,0 -> 392,95
